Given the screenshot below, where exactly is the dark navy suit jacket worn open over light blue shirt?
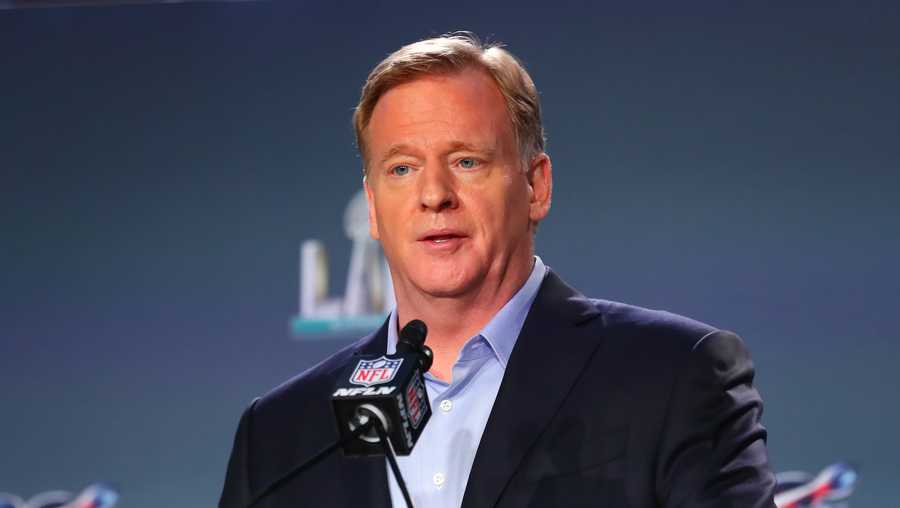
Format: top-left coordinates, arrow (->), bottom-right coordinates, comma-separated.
219,271 -> 775,508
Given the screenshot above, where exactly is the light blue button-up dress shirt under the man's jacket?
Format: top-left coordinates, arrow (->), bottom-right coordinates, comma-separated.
385,256 -> 546,508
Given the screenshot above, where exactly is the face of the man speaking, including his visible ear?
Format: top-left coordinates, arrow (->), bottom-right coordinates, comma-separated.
365,69 -> 550,298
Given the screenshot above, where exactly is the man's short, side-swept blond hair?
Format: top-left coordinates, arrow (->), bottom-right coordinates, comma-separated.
353,32 -> 544,172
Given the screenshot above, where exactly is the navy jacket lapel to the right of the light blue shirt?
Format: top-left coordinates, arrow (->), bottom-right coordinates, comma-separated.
463,270 -> 599,508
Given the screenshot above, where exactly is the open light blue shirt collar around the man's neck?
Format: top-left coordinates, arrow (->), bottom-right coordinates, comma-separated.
387,256 -> 547,368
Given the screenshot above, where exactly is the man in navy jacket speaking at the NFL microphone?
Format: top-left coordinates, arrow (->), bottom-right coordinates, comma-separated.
220,34 -> 774,508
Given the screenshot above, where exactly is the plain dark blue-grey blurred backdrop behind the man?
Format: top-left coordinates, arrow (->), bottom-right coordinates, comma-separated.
0,1 -> 900,508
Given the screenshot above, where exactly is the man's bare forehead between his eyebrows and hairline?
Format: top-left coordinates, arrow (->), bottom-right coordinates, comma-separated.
365,69 -> 514,160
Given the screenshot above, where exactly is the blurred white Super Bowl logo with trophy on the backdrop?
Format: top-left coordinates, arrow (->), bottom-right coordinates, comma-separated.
291,190 -> 394,338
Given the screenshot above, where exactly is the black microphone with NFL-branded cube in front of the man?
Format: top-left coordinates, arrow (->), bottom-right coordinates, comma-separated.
331,319 -> 434,456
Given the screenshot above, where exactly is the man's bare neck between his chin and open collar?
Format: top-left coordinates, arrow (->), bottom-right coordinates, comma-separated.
396,255 -> 534,382
